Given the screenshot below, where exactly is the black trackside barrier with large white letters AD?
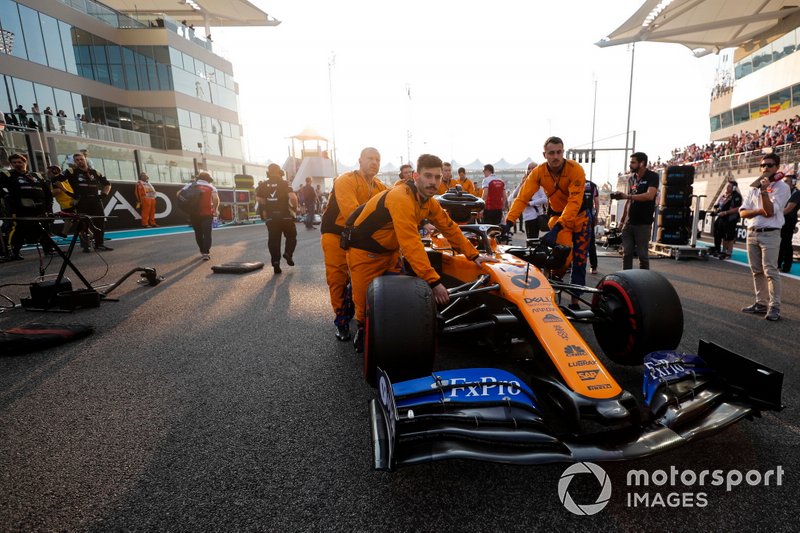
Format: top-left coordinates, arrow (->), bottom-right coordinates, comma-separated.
54,181 -> 234,230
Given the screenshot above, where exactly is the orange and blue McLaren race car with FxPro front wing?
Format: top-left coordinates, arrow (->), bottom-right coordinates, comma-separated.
364,190 -> 783,470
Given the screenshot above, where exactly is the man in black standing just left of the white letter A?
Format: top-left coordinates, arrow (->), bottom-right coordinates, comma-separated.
54,152 -> 113,253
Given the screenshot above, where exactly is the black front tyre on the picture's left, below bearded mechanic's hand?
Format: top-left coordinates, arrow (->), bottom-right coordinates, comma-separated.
364,276 -> 436,387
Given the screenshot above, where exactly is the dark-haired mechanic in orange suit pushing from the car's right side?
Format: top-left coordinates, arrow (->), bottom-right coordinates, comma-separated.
503,137 -> 591,310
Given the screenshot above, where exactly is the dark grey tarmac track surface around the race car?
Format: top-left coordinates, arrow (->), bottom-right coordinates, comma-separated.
0,225 -> 800,531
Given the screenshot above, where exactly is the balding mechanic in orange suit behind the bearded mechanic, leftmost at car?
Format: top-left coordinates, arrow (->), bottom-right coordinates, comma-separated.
320,148 -> 386,341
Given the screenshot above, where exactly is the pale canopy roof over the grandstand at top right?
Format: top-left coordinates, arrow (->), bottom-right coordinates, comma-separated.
595,0 -> 800,57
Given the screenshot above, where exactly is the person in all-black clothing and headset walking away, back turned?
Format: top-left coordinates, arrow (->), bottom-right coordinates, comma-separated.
256,163 -> 296,274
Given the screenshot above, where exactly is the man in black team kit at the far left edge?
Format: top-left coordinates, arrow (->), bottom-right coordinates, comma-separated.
0,154 -> 53,261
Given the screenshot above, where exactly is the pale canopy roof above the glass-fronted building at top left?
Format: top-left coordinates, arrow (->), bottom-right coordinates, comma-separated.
103,0 -> 281,27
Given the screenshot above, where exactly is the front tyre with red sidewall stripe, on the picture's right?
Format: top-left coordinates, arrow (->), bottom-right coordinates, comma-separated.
592,270 -> 683,365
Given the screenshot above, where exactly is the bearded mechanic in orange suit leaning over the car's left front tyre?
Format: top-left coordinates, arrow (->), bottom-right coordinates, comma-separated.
347,154 -> 496,353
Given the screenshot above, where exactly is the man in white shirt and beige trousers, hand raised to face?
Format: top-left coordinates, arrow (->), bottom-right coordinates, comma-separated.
739,154 -> 790,321
